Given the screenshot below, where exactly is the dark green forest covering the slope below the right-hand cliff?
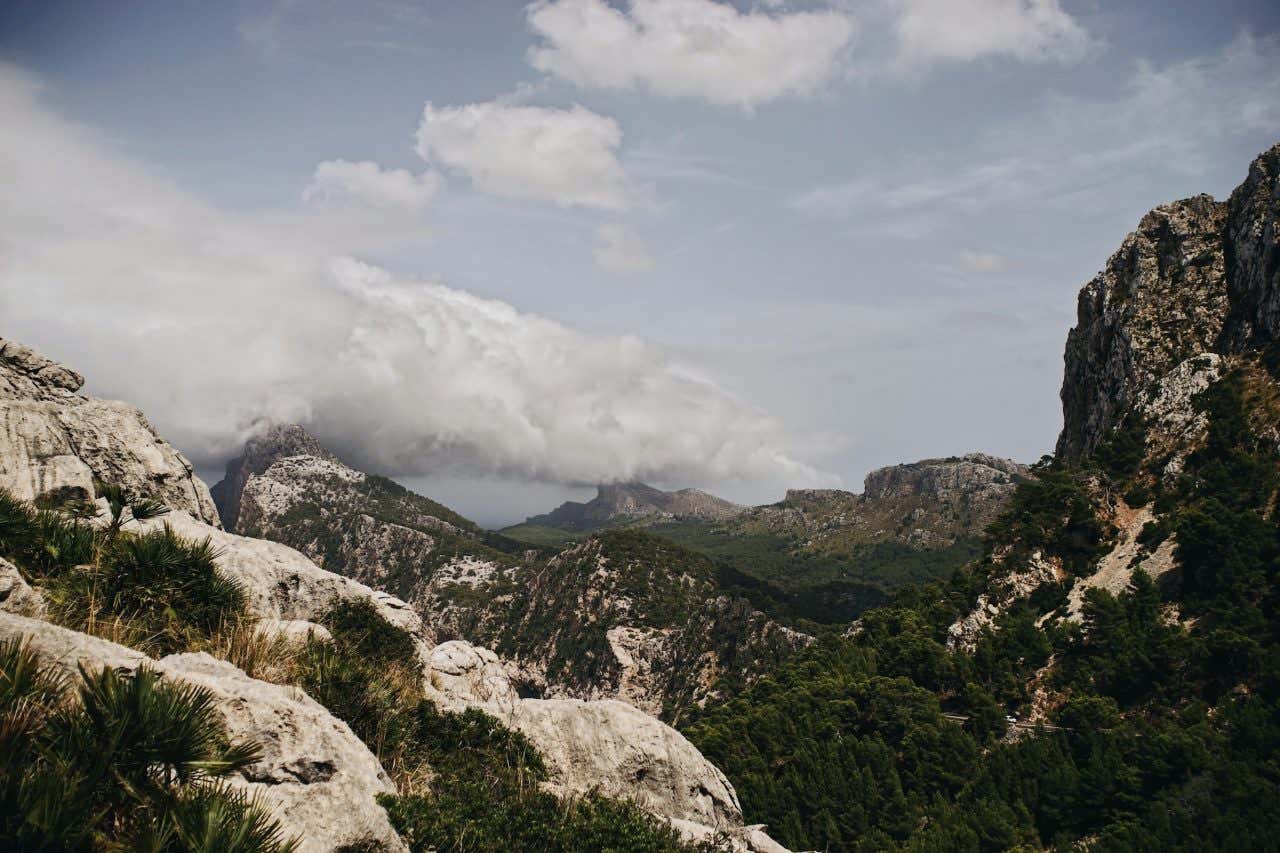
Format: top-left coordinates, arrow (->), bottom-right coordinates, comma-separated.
685,356 -> 1280,850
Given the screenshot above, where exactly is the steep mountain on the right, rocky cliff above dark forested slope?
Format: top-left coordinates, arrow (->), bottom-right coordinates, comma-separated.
682,145 -> 1280,850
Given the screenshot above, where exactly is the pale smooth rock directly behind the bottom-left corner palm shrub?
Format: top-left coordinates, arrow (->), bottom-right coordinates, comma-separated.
0,612 -> 406,853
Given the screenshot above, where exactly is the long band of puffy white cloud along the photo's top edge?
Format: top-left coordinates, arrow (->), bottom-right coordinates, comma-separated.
526,0 -> 1094,110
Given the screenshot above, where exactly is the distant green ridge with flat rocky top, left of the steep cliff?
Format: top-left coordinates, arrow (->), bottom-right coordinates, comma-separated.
519,453 -> 1032,630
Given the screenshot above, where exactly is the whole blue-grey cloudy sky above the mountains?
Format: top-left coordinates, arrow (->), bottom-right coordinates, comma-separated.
0,0 -> 1280,526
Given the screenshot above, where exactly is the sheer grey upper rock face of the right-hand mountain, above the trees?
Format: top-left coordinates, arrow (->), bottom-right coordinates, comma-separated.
1057,145 -> 1280,461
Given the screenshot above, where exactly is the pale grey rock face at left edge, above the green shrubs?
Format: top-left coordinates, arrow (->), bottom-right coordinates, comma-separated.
0,338 -> 220,526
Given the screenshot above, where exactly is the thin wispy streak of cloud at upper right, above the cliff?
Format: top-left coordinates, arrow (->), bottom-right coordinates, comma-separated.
792,35 -> 1280,228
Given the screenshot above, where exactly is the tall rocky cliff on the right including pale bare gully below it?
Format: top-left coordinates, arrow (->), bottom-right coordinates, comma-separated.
950,145 -> 1280,647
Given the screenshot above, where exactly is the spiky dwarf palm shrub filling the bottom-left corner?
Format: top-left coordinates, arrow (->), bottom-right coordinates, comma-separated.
0,640 -> 296,853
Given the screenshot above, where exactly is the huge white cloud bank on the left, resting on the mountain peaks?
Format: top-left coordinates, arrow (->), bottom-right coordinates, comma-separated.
0,67 -> 813,483
